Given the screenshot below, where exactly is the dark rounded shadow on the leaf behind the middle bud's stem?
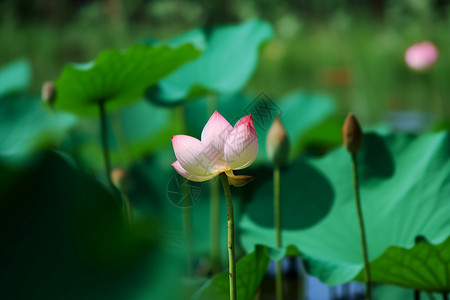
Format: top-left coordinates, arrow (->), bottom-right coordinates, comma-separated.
245,160 -> 334,230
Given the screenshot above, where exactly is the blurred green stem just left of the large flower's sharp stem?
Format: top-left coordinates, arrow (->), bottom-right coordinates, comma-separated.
209,178 -> 220,274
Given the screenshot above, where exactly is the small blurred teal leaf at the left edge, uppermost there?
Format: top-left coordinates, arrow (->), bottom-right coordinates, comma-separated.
0,59 -> 31,97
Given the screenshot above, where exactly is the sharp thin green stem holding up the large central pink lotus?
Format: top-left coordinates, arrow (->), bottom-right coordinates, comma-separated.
220,173 -> 237,300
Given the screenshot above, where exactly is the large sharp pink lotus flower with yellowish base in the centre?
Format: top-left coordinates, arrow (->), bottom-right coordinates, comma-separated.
172,111 -> 258,186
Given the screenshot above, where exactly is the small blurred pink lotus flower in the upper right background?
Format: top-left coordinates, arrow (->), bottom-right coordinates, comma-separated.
405,41 -> 439,71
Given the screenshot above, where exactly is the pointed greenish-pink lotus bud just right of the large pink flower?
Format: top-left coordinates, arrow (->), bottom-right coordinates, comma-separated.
266,116 -> 289,167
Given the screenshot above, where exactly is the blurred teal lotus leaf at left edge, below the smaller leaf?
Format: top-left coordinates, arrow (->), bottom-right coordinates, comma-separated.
0,94 -> 77,159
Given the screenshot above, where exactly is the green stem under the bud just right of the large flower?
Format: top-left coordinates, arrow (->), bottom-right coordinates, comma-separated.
273,167 -> 283,300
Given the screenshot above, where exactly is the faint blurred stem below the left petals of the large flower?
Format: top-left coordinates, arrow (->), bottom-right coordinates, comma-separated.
181,178 -> 194,277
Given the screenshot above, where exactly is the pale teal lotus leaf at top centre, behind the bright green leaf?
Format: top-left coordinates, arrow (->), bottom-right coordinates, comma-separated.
150,20 -> 273,103
